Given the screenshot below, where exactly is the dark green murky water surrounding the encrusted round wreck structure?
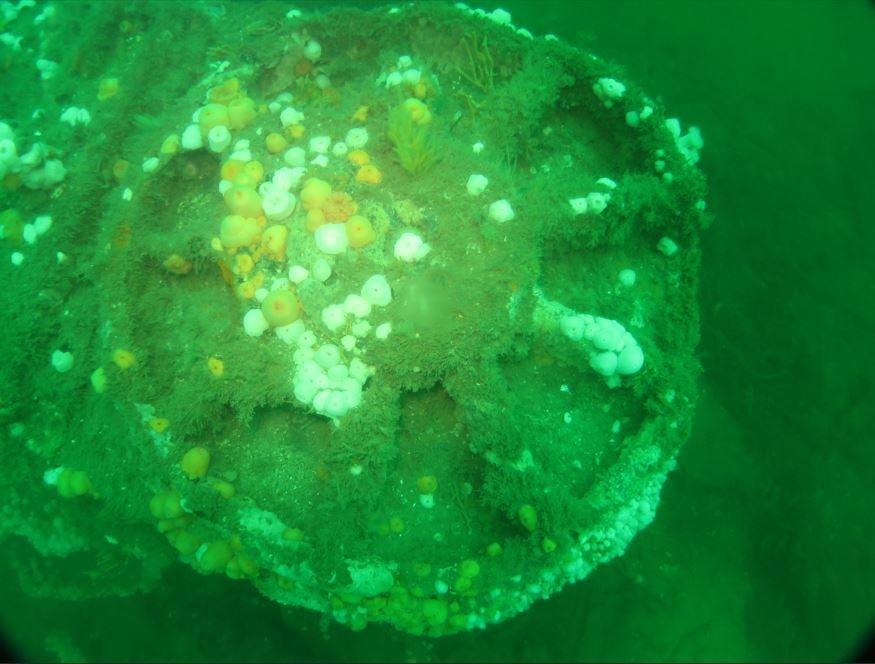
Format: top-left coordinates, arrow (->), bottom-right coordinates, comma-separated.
0,0 -> 875,661
